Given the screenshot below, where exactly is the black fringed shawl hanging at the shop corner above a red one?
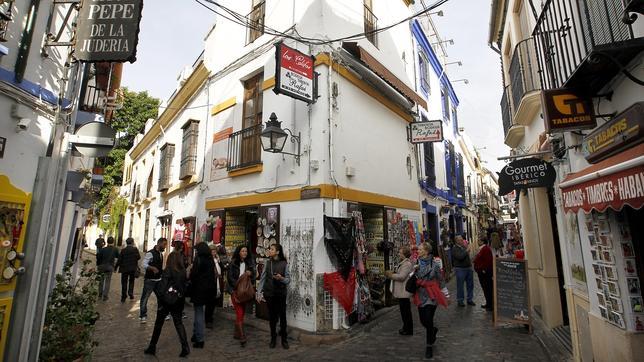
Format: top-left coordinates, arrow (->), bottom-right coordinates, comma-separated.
324,216 -> 355,280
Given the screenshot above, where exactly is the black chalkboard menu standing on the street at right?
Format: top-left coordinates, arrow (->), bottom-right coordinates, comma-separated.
494,258 -> 531,325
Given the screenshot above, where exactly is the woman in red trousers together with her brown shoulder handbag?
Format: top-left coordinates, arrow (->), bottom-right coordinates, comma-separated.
227,246 -> 255,347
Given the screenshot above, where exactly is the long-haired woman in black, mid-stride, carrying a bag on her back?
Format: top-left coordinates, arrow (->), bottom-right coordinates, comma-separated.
143,251 -> 190,357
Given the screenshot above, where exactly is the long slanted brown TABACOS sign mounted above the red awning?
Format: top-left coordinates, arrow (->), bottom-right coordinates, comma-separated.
583,102 -> 644,163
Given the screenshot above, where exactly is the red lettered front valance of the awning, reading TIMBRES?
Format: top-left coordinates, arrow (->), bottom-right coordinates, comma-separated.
561,166 -> 644,213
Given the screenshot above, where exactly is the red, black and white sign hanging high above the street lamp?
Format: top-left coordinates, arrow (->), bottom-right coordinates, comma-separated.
273,42 -> 317,103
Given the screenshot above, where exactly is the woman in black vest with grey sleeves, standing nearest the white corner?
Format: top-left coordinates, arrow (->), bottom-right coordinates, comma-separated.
257,244 -> 291,349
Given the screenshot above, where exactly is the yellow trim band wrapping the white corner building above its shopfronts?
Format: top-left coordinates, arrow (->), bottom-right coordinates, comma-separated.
206,184 -> 420,210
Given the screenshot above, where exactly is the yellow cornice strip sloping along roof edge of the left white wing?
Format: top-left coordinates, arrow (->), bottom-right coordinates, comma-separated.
130,62 -> 210,161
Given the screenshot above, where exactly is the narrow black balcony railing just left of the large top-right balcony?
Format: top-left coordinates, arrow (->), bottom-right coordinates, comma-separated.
510,38 -> 541,112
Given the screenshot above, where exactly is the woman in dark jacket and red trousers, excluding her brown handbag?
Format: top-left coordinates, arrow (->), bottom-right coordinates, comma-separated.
227,246 -> 255,347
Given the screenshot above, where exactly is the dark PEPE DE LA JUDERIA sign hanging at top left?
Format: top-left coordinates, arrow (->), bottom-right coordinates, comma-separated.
74,0 -> 143,63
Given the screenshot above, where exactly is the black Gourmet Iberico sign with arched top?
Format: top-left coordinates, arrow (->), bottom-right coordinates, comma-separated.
499,158 -> 557,196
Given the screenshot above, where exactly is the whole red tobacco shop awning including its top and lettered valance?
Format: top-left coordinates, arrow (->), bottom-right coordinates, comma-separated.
559,144 -> 644,213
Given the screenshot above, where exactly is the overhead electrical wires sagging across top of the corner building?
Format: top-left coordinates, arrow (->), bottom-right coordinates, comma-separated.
195,0 -> 448,45
